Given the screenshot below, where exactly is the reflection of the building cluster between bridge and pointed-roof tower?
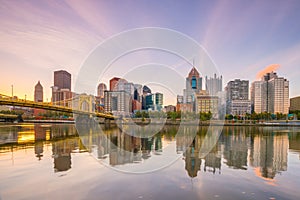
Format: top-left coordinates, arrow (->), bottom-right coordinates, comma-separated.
81,124 -> 163,166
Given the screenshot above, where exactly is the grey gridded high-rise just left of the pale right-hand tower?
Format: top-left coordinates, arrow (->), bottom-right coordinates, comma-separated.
225,79 -> 251,115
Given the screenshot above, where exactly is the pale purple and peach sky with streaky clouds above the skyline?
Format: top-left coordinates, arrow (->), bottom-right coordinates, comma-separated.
0,0 -> 300,104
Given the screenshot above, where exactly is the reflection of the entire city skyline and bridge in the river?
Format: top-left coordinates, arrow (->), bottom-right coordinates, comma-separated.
0,124 -> 300,179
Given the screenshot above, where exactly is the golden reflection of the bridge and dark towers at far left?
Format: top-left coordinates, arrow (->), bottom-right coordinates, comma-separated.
0,124 -> 81,172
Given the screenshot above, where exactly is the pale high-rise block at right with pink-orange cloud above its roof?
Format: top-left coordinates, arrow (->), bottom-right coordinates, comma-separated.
251,72 -> 290,114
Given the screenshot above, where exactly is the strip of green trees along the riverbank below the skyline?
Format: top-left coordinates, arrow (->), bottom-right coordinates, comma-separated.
0,111 -> 300,126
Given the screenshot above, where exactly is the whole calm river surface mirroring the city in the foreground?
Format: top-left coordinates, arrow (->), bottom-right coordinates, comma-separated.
0,124 -> 300,200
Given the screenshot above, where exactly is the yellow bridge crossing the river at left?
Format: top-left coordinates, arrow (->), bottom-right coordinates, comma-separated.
0,94 -> 116,119
